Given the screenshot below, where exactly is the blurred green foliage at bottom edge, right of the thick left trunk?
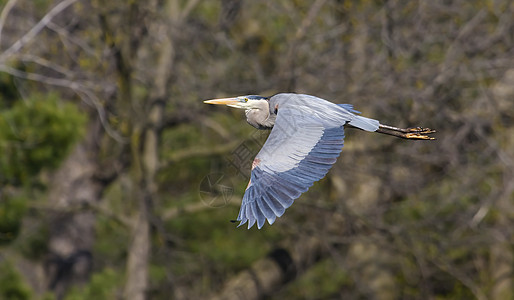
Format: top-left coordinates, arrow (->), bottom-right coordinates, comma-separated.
65,268 -> 123,300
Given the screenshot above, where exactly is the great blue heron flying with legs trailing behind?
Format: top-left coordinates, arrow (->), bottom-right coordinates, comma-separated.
204,93 -> 435,229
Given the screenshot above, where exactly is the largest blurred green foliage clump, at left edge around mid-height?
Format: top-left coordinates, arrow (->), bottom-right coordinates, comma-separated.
0,94 -> 86,185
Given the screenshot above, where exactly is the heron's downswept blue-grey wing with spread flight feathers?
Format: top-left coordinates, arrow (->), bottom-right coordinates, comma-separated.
237,99 -> 351,229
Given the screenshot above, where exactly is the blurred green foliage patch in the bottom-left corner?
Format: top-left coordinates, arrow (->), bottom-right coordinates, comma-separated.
0,262 -> 32,300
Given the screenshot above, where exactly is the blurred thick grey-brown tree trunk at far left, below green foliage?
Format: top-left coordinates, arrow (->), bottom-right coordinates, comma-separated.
45,118 -> 105,299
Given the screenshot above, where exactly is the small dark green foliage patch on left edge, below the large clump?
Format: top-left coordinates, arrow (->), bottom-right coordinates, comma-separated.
0,194 -> 26,246
